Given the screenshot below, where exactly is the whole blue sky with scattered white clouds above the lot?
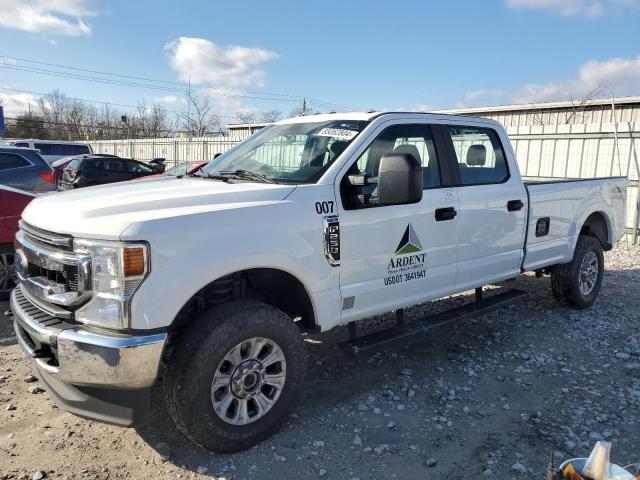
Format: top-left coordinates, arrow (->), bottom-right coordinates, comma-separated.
0,0 -> 640,118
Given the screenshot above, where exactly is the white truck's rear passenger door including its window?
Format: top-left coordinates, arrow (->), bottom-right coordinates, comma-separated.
443,125 -> 527,291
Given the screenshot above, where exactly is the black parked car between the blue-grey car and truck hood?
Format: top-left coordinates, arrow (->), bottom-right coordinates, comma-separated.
58,155 -> 158,191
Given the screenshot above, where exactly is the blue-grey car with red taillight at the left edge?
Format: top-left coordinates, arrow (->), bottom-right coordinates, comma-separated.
0,146 -> 56,192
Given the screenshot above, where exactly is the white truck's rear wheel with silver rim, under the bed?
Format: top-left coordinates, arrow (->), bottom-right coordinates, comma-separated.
551,235 -> 604,309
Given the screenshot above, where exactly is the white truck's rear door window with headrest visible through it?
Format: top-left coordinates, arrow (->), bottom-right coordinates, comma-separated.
448,127 -> 509,185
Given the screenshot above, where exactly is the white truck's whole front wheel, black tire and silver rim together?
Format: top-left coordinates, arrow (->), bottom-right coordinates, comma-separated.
165,301 -> 305,452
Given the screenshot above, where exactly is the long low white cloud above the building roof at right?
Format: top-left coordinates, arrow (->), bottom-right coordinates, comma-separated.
459,56 -> 640,106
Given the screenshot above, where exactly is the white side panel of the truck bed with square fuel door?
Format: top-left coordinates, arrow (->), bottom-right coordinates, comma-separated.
523,177 -> 628,270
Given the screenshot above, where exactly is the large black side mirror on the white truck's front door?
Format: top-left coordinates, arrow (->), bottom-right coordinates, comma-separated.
378,153 -> 422,205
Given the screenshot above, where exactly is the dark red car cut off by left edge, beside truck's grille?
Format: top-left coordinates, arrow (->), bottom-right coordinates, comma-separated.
0,185 -> 36,300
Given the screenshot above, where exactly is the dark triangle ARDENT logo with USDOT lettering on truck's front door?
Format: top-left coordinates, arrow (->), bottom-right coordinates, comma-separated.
384,224 -> 427,285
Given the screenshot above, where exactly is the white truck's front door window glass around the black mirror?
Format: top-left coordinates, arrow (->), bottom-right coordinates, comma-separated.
341,125 -> 440,209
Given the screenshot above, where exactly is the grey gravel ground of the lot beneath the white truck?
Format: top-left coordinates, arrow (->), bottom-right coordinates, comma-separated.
0,243 -> 640,480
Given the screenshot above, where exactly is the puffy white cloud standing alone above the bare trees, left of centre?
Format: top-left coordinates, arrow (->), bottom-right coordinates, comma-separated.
165,37 -> 278,87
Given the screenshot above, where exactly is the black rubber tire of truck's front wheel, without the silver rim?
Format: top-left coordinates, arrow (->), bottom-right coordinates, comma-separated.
164,300 -> 306,453
